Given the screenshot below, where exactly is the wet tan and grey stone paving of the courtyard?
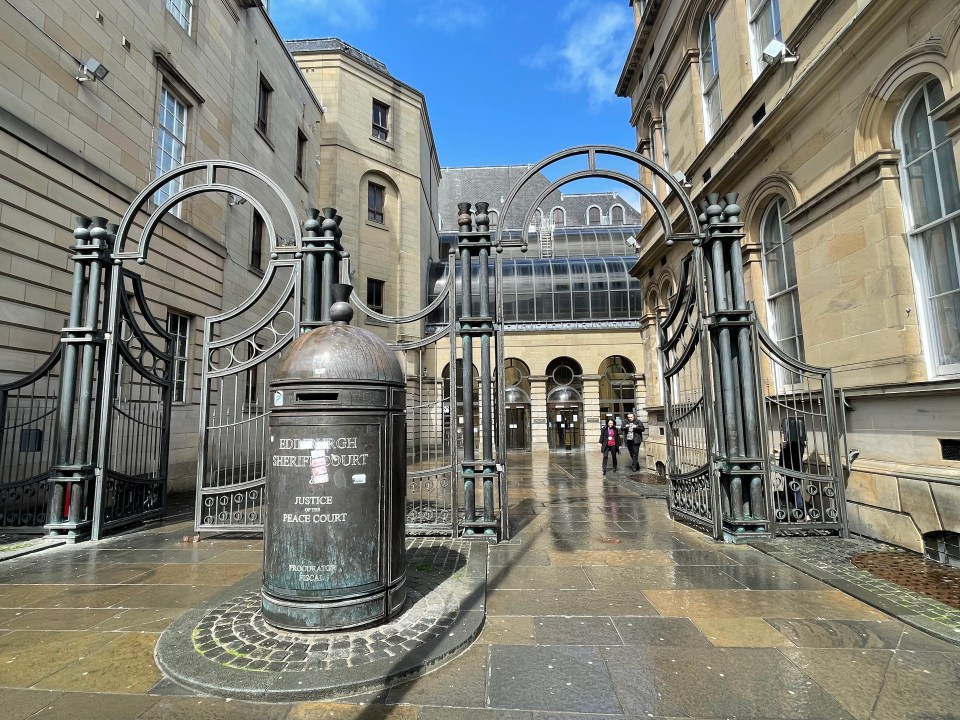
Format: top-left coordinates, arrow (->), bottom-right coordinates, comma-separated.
0,453 -> 960,720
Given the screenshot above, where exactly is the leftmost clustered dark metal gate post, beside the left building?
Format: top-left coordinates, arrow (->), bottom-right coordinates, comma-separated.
44,216 -> 117,541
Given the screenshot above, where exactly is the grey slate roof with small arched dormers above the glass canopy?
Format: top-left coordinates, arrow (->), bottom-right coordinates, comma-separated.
440,165 -> 641,231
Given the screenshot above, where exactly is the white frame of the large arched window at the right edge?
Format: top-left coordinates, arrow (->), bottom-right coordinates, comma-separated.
894,79 -> 960,378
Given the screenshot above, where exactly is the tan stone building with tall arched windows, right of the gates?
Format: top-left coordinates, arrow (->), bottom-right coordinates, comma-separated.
616,0 -> 960,561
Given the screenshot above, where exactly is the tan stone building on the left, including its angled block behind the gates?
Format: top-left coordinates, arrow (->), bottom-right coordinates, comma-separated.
0,0 -> 439,496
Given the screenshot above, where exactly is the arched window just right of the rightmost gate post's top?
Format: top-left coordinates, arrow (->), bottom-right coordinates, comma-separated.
760,197 -> 803,360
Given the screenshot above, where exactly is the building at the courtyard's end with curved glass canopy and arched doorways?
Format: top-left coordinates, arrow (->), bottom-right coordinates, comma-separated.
428,166 -> 644,450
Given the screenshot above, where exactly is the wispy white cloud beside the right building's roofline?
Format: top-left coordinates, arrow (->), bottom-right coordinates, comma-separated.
531,0 -> 633,107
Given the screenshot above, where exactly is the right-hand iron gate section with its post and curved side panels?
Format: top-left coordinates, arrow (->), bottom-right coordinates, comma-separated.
659,194 -> 847,542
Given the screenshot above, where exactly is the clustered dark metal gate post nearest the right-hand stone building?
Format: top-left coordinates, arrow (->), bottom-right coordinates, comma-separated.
703,193 -> 770,542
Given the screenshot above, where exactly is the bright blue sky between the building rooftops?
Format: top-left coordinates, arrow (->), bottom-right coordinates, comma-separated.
270,0 -> 636,167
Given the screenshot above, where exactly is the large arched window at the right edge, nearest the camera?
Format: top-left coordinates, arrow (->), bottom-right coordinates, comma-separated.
896,80 -> 960,375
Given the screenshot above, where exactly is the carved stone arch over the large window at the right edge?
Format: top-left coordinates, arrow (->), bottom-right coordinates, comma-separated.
854,40 -> 960,163
